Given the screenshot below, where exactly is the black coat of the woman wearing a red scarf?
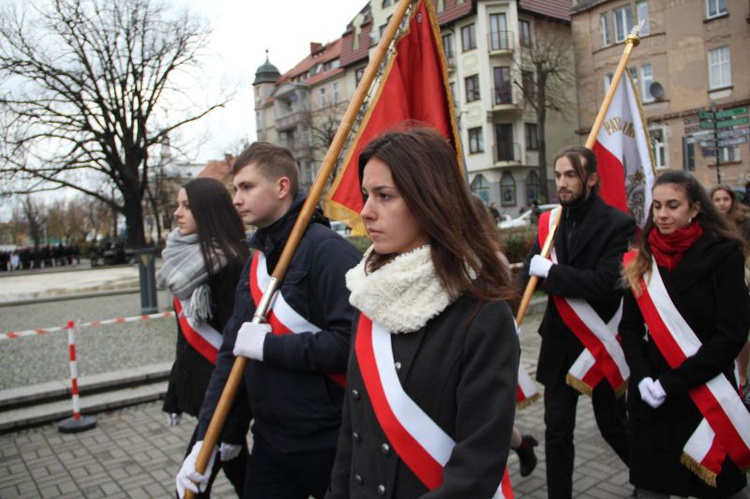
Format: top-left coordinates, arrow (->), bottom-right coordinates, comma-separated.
620,233 -> 750,498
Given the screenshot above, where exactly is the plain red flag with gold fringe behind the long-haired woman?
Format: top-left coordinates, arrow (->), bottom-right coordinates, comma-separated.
324,0 -> 463,233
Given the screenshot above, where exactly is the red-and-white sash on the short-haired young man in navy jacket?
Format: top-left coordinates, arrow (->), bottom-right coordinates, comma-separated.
250,254 -> 346,386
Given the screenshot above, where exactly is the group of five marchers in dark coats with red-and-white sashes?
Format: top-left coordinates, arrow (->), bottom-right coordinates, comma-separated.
157,122 -> 750,499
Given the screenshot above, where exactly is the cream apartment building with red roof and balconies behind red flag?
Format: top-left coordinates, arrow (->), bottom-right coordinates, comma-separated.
253,0 -> 579,211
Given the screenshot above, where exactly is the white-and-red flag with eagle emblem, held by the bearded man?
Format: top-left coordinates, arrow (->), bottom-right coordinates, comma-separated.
592,72 -> 654,227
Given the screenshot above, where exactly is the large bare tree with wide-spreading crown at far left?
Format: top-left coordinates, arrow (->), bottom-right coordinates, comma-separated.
0,0 -> 226,248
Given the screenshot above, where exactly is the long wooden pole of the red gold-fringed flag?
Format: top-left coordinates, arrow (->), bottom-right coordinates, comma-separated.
185,0 -> 421,498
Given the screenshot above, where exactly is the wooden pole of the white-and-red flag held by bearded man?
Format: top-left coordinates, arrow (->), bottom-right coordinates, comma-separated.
516,32 -> 641,326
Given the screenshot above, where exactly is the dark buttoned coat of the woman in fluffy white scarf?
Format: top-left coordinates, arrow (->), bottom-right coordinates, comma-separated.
326,296 -> 520,499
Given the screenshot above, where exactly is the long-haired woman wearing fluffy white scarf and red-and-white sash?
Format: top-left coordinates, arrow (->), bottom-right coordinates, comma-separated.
326,128 -> 519,499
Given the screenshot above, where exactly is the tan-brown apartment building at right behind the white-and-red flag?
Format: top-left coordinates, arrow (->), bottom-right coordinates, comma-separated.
571,0 -> 750,186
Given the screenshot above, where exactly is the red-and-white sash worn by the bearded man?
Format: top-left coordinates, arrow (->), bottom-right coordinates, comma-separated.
539,207 -> 630,395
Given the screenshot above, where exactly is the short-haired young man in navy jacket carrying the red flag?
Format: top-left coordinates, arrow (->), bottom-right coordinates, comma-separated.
177,142 -> 360,499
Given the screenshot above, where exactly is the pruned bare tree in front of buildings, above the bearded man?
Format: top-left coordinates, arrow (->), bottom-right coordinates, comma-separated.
513,23 -> 575,200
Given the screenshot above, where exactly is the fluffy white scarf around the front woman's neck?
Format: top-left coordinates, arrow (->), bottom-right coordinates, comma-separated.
346,246 -> 453,334
